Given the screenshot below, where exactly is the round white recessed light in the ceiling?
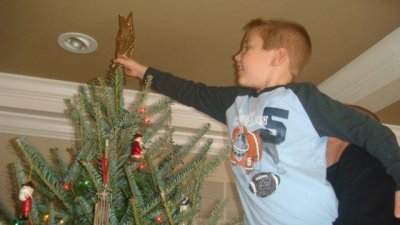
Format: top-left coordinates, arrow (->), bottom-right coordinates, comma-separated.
57,32 -> 98,54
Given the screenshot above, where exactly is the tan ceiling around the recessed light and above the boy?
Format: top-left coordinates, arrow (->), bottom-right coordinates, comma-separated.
0,0 -> 400,125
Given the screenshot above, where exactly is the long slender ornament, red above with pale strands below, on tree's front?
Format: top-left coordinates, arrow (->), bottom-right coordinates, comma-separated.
93,140 -> 111,225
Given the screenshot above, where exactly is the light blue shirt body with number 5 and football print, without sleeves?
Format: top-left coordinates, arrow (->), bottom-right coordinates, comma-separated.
227,87 -> 337,225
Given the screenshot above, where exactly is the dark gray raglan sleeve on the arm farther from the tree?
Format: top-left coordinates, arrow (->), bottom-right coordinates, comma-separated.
293,84 -> 400,190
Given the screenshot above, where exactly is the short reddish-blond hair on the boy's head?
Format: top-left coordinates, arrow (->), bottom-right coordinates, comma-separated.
244,18 -> 311,77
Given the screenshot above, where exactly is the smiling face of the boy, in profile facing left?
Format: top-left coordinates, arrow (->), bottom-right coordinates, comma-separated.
234,28 -> 275,91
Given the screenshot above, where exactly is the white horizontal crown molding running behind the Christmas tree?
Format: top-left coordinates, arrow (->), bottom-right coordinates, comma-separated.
0,73 -> 227,153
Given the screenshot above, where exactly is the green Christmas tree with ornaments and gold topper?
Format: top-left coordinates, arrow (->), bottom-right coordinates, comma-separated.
0,14 -> 239,225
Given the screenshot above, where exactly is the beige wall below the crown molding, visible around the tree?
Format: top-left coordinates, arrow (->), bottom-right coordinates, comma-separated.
0,133 -> 242,223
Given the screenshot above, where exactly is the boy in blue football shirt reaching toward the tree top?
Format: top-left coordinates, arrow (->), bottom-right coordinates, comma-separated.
114,19 -> 400,225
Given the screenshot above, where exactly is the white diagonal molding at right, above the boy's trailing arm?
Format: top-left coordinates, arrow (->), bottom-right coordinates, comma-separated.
318,27 -> 400,112
